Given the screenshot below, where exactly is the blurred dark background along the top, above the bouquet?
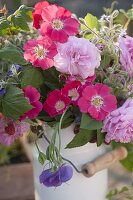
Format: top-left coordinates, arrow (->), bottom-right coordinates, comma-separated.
0,0 -> 133,17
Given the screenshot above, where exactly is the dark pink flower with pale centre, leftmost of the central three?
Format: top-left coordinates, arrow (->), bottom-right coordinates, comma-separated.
44,90 -> 71,117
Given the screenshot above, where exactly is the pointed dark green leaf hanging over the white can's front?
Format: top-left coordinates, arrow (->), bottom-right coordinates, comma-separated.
66,129 -> 96,148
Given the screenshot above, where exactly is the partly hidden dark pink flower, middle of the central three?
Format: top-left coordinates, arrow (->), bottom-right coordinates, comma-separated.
62,81 -> 82,106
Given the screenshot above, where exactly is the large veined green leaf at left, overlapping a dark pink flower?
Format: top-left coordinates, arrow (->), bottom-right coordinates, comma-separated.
2,86 -> 32,120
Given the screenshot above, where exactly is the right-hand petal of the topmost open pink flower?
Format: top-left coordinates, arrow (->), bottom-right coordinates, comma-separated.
64,18 -> 80,35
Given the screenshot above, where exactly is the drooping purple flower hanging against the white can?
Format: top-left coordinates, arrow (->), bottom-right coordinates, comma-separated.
39,164 -> 73,187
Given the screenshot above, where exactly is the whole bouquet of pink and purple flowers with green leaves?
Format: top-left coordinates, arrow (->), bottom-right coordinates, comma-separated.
0,1 -> 133,199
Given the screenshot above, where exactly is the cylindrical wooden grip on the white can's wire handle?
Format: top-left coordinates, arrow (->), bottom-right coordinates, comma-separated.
82,146 -> 128,177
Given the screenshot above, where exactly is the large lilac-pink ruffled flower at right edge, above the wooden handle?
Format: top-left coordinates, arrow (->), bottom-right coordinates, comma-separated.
102,98 -> 133,143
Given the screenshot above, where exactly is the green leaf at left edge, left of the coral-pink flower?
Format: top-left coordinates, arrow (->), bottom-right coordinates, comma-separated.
0,44 -> 26,65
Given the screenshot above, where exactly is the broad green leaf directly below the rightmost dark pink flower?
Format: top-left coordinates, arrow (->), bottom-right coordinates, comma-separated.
80,113 -> 103,130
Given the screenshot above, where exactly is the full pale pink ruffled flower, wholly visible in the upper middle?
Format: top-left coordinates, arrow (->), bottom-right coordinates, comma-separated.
54,37 -> 101,79
